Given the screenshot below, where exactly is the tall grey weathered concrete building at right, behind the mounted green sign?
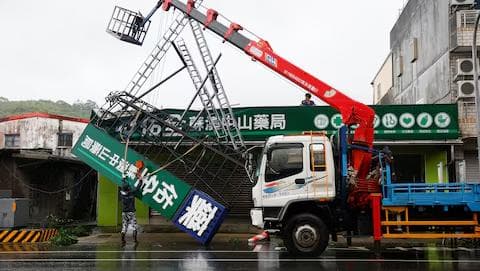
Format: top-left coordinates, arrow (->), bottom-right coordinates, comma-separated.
372,0 -> 480,184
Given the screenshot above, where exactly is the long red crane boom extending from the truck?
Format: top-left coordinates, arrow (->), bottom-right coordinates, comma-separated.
150,0 -> 375,179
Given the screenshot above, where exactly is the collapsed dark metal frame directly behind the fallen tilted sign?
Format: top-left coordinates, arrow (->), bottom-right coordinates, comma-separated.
92,92 -> 251,214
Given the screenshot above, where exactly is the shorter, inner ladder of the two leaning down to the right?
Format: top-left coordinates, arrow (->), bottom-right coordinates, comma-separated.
175,39 -> 229,143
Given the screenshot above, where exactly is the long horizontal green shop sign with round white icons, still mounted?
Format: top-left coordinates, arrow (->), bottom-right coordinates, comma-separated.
155,104 -> 459,141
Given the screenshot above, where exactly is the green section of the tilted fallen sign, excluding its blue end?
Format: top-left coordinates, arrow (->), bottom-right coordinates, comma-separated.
73,124 -> 191,219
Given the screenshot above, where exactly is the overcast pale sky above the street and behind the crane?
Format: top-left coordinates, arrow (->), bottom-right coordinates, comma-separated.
0,0 -> 406,107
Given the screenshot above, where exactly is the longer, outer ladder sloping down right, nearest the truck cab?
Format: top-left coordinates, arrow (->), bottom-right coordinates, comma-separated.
189,19 -> 245,150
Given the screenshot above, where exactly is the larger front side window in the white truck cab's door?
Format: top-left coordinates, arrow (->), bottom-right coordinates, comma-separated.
265,144 -> 303,182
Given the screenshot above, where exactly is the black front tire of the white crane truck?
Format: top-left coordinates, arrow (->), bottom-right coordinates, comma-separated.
283,213 -> 329,256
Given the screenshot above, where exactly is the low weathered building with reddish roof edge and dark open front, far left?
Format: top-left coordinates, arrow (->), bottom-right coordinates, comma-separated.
0,113 -> 96,223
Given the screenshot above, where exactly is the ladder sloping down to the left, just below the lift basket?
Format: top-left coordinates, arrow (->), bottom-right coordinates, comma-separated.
125,0 -> 203,95
